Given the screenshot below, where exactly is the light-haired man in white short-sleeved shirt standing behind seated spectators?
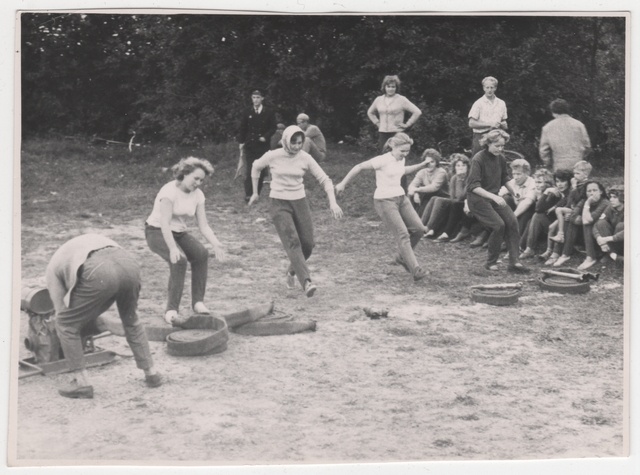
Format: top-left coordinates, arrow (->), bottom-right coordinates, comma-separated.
469,76 -> 507,157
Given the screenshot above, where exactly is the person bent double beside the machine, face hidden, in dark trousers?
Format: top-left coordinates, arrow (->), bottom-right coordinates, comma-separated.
46,234 -> 162,399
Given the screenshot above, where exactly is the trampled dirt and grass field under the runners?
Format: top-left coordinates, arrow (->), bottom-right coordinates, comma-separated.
10,142 -> 624,465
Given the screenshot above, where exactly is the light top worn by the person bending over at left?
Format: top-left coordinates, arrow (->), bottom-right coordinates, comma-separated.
46,234 -> 120,312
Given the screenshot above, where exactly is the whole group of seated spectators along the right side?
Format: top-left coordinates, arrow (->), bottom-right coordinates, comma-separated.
407,149 -> 624,270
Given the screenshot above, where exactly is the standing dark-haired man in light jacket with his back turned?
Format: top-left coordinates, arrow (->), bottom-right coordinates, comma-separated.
539,99 -> 591,172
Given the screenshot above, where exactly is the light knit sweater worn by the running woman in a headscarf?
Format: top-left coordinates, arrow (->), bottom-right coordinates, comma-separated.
251,148 -> 333,200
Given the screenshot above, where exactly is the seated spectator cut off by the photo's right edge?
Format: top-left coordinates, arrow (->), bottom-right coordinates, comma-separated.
593,185 -> 624,261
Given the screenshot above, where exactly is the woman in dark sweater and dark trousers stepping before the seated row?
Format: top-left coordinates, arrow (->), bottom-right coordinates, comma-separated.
467,129 -> 529,273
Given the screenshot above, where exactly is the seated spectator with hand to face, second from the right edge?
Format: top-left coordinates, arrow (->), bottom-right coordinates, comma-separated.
553,181 -> 611,270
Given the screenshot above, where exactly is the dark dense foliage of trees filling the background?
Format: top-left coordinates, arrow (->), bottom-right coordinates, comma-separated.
21,13 -> 626,166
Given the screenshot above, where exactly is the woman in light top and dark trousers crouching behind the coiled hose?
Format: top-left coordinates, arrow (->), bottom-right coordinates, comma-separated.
145,157 -> 225,324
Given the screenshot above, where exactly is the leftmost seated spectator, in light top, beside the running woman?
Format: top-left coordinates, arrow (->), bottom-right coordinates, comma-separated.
407,148 -> 449,216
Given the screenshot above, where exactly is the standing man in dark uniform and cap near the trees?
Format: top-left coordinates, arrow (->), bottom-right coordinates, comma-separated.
238,89 -> 276,203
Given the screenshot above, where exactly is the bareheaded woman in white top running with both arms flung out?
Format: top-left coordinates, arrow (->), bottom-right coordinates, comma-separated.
336,133 -> 427,281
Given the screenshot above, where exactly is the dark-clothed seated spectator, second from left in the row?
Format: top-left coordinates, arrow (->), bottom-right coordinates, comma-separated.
422,153 -> 471,242
